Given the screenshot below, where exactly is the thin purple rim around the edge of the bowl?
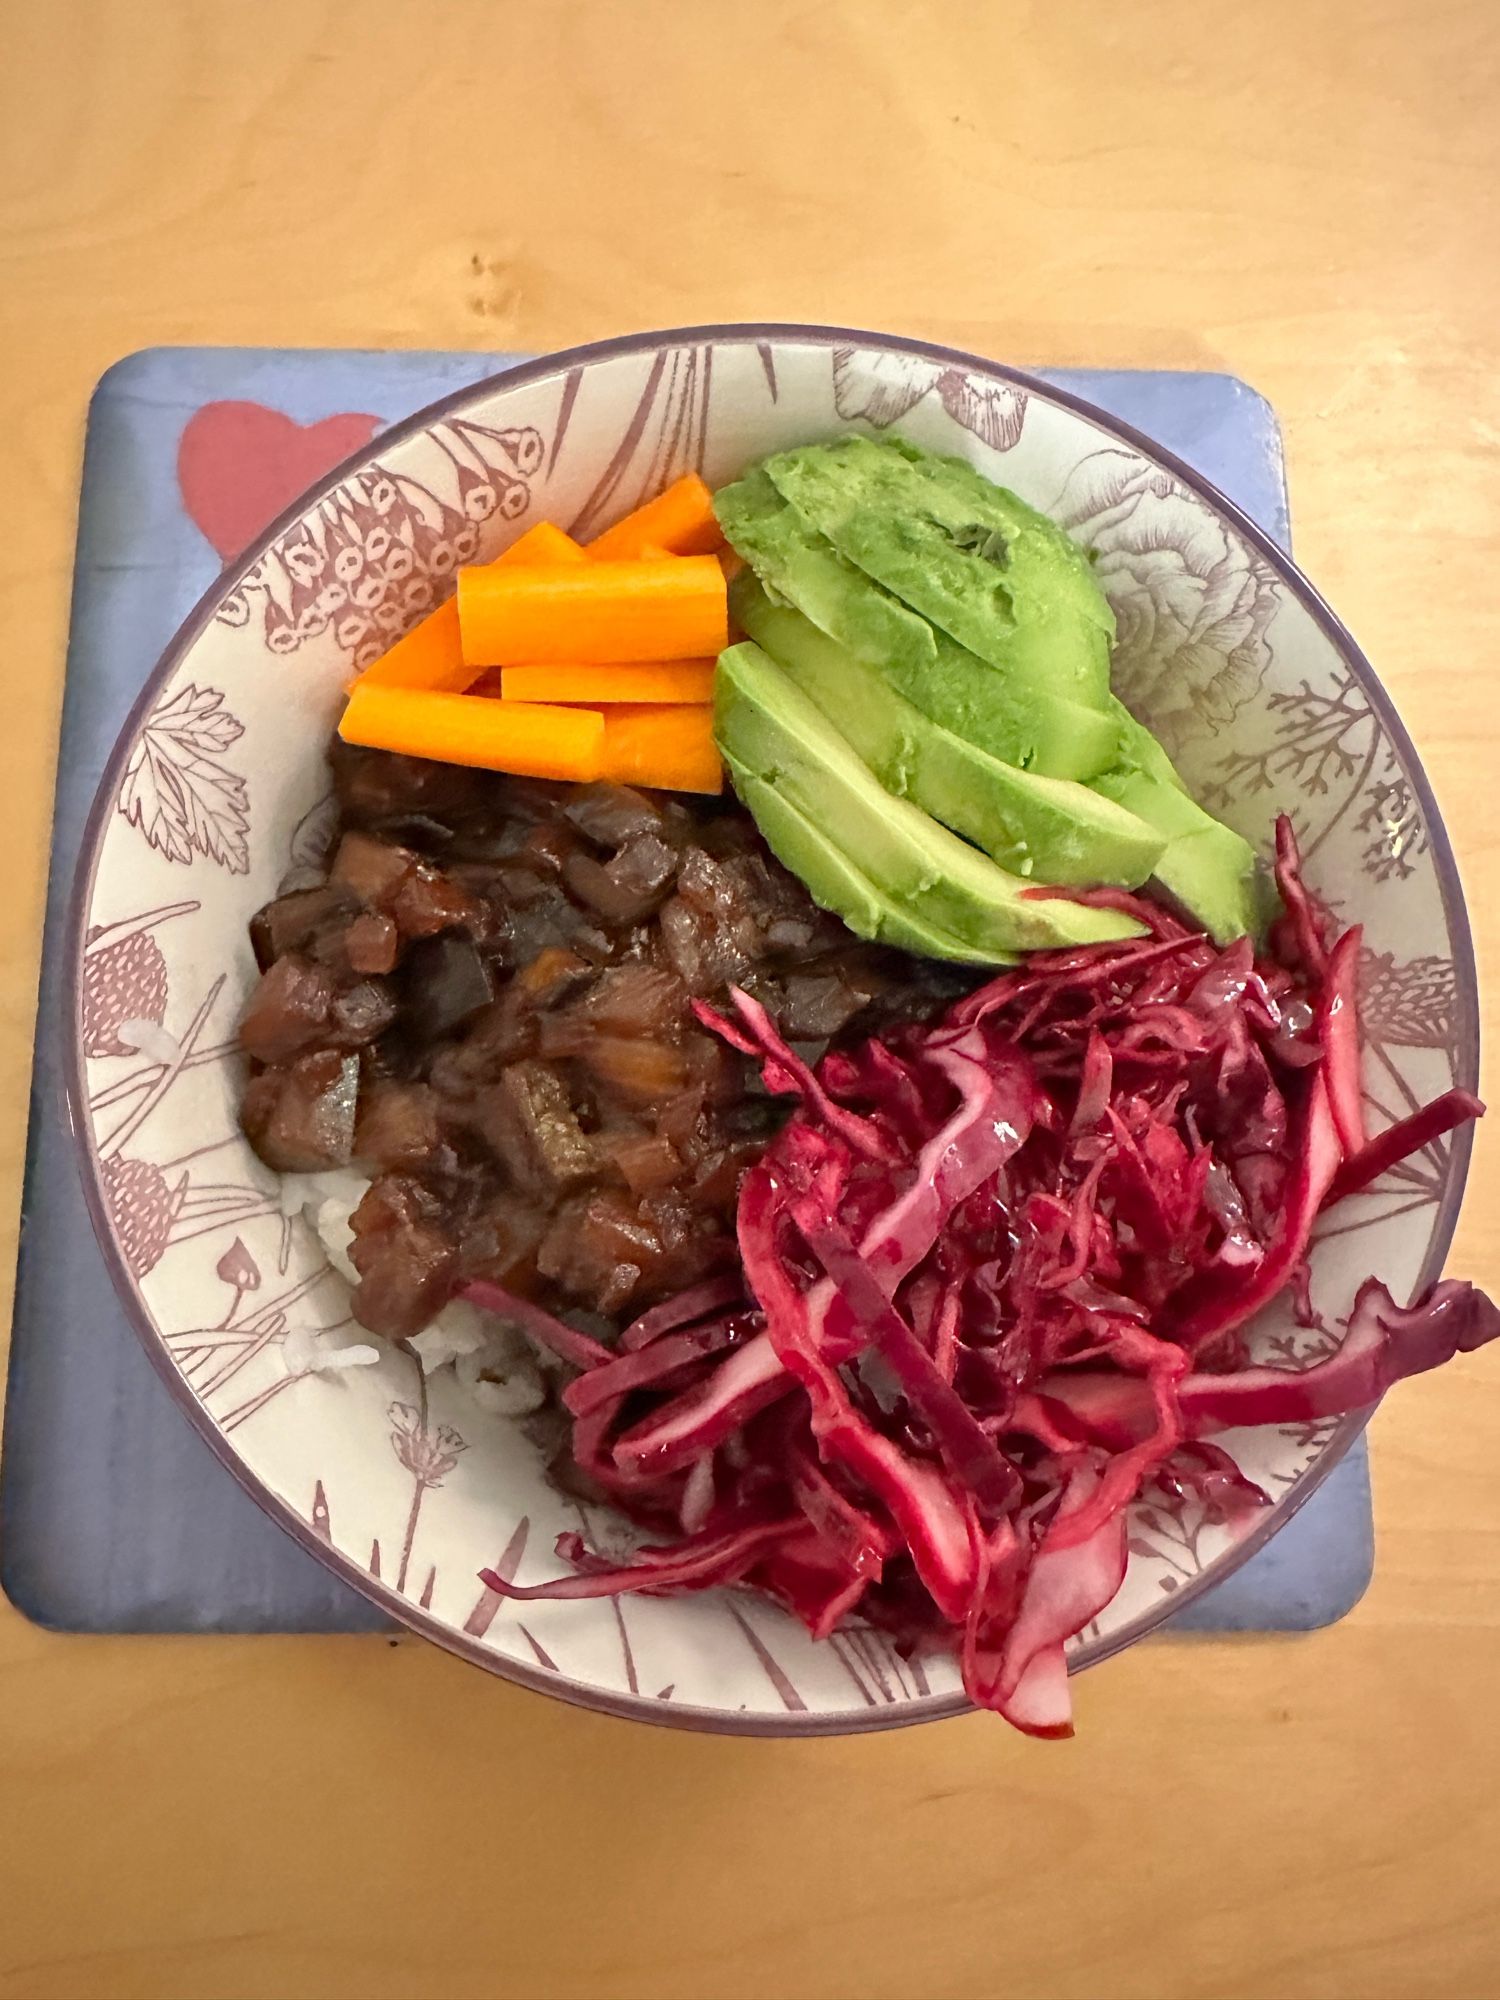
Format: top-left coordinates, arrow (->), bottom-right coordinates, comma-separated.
64,322 -> 1480,1736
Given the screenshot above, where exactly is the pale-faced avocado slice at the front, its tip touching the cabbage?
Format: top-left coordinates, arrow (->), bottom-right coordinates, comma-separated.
714,644 -> 1140,962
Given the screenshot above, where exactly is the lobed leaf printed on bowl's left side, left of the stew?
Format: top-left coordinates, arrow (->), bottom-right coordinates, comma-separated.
116,682 -> 250,874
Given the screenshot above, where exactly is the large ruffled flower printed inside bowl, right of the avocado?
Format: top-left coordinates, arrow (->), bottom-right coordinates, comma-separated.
1050,448 -> 1278,756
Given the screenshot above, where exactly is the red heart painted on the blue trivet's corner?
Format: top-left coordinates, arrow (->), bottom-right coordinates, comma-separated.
178,402 -> 382,562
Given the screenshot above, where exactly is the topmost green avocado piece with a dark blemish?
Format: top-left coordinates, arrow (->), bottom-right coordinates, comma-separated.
768,436 -> 1114,708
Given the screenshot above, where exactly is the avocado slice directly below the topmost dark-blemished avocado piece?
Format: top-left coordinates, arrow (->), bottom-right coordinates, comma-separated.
714,492 -> 1136,780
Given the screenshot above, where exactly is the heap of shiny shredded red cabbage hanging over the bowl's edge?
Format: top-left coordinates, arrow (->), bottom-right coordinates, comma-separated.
468,820 -> 1500,1736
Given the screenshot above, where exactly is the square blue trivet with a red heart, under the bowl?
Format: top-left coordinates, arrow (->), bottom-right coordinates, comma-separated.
0,348 -> 1372,1632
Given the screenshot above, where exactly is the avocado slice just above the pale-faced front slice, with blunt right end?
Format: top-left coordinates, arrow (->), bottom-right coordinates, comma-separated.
734,576 -> 1166,888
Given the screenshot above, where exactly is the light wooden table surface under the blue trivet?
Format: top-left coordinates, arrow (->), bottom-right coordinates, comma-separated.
0,0 -> 1500,2000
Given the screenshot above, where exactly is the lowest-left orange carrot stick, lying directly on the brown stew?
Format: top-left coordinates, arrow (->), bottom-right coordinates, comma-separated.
338,682 -> 604,782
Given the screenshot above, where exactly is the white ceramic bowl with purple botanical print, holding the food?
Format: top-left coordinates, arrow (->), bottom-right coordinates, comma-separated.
70,326 -> 1478,1734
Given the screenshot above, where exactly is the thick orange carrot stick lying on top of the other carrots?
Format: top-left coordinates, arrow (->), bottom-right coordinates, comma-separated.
458,556 -> 728,668
